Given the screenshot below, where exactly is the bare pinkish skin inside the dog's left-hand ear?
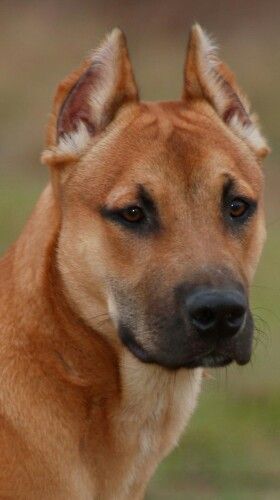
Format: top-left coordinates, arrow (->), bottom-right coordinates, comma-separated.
57,65 -> 99,139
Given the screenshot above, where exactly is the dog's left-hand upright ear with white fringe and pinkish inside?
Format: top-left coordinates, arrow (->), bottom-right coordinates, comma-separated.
42,28 -> 139,166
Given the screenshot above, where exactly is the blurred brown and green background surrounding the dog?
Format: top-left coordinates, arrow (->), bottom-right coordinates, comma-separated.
0,0 -> 280,500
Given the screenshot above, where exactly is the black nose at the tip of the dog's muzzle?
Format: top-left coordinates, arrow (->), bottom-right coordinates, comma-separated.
185,289 -> 247,337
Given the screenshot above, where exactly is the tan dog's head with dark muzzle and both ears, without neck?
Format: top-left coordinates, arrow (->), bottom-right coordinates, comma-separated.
43,26 -> 267,368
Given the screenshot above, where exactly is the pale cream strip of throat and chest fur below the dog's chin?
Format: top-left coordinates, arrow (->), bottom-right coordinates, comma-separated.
105,358 -> 201,498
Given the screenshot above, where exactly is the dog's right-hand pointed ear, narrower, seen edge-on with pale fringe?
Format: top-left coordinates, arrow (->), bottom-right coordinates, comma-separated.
183,24 -> 269,158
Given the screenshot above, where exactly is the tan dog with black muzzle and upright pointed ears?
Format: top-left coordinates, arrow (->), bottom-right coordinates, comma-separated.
0,25 -> 268,500
